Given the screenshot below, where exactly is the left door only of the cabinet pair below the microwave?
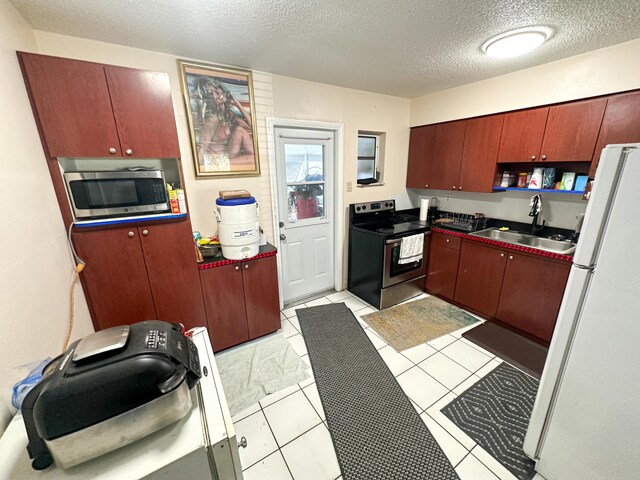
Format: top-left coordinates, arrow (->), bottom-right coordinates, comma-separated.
73,227 -> 157,330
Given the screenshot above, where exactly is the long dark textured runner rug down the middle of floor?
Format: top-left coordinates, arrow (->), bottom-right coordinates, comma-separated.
296,303 -> 458,480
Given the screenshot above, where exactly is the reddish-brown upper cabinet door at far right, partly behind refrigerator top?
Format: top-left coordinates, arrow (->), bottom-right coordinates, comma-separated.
589,92 -> 640,177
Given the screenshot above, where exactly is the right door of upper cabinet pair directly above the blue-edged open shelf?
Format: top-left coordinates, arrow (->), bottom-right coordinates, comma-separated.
540,98 -> 607,162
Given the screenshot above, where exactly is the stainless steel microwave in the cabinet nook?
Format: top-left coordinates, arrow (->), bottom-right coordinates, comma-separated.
64,170 -> 171,219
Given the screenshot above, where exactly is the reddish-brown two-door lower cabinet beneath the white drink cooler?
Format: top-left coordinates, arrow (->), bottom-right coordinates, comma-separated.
200,256 -> 280,352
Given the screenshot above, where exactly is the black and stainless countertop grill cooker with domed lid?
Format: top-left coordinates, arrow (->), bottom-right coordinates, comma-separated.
22,320 -> 200,470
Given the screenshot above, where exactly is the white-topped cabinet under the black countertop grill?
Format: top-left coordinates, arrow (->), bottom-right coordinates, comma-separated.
0,327 -> 244,480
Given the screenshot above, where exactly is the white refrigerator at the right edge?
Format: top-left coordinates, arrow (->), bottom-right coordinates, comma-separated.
524,144 -> 640,480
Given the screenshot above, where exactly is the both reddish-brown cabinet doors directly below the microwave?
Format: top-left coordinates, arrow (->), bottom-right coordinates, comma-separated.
73,222 -> 206,330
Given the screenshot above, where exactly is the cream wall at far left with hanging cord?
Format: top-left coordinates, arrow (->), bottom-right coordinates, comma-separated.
0,2 -> 93,368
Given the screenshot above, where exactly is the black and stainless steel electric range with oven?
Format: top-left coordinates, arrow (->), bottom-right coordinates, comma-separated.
348,200 -> 430,309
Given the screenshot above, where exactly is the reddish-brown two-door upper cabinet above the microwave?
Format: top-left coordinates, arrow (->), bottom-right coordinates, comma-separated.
18,52 -> 180,158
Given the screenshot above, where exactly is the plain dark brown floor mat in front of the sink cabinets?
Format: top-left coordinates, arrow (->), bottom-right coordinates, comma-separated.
462,322 -> 549,380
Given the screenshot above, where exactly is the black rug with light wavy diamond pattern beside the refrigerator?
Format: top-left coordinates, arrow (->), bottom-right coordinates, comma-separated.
441,363 -> 538,480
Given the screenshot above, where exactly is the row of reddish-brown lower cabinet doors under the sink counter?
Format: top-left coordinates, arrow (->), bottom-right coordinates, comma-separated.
426,232 -> 571,343
